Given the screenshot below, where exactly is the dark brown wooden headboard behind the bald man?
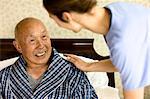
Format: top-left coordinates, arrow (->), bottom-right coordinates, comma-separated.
0,38 -> 115,87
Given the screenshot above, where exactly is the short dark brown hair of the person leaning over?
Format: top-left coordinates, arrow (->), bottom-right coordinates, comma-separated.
43,0 -> 97,21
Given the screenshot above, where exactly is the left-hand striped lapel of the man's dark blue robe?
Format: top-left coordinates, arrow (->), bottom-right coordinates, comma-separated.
10,56 -> 33,99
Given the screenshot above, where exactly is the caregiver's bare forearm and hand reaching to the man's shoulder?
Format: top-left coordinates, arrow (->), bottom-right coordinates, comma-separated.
66,54 -> 118,72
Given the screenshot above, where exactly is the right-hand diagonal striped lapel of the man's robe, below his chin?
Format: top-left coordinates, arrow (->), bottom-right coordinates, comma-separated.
34,50 -> 70,98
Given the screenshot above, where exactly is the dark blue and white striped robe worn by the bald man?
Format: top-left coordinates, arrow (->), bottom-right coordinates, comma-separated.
0,50 -> 98,99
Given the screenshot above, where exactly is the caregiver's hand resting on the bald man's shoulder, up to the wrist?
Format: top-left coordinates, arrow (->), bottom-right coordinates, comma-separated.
65,54 -> 90,72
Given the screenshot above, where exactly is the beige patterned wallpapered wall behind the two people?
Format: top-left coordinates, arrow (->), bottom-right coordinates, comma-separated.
0,0 -> 150,98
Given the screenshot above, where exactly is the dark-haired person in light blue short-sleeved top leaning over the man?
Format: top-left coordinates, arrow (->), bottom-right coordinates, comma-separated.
43,0 -> 150,99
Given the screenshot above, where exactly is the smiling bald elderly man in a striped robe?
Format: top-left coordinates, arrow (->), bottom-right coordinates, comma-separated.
0,18 -> 97,99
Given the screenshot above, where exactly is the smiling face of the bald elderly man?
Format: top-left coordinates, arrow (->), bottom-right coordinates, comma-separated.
15,21 -> 52,66
